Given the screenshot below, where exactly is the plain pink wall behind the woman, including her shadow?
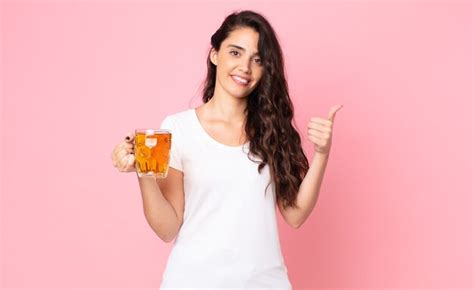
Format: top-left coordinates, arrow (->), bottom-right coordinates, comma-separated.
0,1 -> 473,289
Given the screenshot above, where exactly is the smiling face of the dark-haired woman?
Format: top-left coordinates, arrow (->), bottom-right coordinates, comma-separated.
210,27 -> 263,98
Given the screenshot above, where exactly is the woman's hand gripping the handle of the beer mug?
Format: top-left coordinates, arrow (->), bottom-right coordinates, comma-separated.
112,132 -> 136,172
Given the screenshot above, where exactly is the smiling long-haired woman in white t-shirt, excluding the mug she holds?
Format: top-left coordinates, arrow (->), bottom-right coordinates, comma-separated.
112,11 -> 342,289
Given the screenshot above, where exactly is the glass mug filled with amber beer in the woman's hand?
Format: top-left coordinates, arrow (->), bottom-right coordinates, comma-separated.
134,129 -> 171,178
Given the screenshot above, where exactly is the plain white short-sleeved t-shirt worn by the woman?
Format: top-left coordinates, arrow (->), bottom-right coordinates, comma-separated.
160,109 -> 292,290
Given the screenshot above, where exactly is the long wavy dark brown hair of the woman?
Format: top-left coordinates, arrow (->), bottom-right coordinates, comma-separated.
202,10 -> 309,208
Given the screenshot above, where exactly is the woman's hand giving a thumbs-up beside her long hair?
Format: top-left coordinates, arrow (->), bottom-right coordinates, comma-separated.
308,105 -> 343,155
